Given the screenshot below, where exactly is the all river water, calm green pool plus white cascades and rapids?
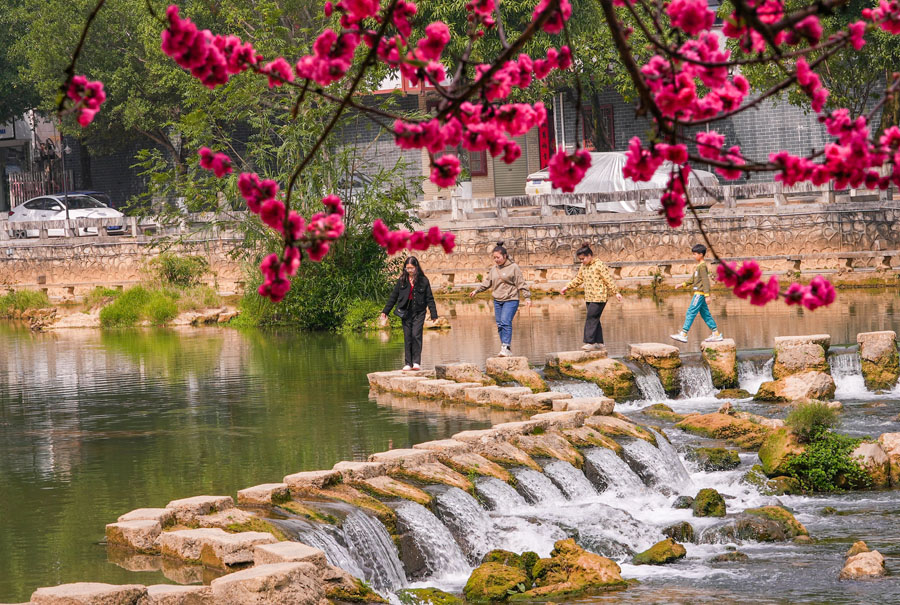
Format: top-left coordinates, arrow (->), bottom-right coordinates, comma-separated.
0,292 -> 900,604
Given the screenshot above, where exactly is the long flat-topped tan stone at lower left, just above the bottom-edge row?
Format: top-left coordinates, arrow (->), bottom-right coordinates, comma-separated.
159,528 -> 278,568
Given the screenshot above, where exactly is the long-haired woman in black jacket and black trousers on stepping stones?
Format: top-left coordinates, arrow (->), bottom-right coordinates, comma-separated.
381,256 -> 437,370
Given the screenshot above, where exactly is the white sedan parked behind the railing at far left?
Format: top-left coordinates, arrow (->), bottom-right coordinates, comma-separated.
9,193 -> 125,238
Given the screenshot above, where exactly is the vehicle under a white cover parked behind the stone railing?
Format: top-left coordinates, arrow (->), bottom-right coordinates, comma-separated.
525,151 -> 719,214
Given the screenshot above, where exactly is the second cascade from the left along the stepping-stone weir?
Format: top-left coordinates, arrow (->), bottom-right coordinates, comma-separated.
343,510 -> 408,590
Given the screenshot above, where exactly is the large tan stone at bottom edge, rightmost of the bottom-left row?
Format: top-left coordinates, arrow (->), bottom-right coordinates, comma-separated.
210,563 -> 325,605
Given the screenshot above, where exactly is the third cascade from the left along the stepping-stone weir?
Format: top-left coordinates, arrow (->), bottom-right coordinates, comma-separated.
398,501 -> 471,577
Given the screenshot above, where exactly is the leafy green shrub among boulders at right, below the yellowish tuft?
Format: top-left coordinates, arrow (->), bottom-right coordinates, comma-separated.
785,431 -> 871,492
